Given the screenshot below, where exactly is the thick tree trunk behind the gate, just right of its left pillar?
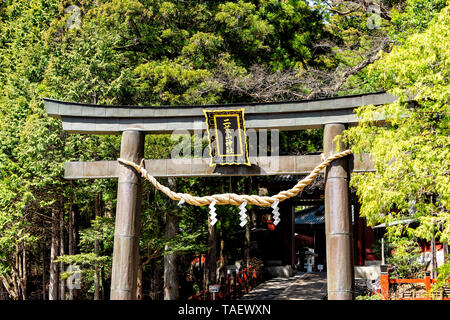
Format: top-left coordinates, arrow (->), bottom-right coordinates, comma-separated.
164,178 -> 179,300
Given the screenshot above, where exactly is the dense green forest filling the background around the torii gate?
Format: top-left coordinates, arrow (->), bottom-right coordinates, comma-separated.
0,0 -> 450,300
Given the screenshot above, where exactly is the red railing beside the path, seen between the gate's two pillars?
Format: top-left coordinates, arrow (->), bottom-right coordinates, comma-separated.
188,266 -> 263,300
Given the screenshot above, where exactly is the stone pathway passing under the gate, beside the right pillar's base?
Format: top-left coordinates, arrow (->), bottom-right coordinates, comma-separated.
240,272 -> 327,300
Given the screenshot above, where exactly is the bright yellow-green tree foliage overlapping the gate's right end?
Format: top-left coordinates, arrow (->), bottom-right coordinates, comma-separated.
346,7 -> 450,241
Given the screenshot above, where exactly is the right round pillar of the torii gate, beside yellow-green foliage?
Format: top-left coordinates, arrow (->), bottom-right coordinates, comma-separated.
324,124 -> 355,300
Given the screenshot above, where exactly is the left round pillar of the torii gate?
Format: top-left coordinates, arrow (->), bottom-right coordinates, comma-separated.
111,130 -> 145,300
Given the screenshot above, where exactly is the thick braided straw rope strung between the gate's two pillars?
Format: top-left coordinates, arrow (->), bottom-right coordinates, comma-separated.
117,150 -> 352,207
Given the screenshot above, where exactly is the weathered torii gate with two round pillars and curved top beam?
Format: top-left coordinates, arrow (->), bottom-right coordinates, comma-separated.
44,93 -> 395,300
